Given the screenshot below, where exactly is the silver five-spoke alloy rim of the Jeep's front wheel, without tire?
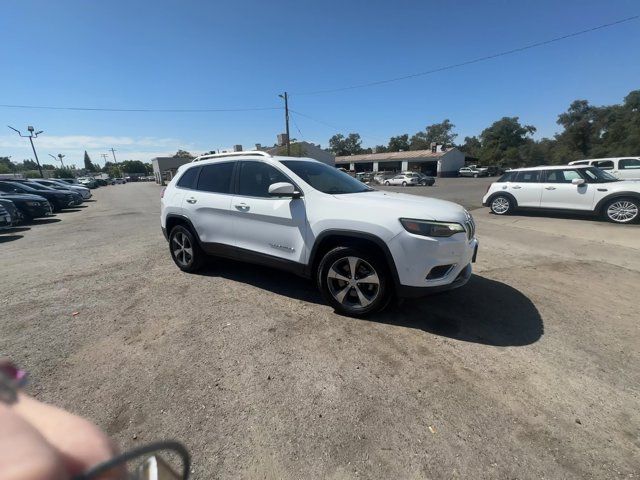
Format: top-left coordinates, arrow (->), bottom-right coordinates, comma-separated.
327,256 -> 380,310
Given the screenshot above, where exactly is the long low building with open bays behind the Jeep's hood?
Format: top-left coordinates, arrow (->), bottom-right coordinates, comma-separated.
335,145 -> 464,177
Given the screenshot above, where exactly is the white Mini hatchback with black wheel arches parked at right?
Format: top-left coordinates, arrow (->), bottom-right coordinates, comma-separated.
482,165 -> 640,223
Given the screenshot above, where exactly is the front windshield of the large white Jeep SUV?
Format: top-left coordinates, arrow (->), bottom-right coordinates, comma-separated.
282,160 -> 373,195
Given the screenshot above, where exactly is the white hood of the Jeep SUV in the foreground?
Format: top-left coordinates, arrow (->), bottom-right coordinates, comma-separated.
333,190 -> 467,224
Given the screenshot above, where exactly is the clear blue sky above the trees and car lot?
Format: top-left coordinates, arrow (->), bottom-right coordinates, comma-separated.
0,0 -> 640,165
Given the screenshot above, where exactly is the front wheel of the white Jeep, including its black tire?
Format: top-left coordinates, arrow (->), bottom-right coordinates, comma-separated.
316,247 -> 391,317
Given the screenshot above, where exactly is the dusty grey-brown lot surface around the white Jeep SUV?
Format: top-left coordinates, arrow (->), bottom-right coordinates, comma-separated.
0,179 -> 640,479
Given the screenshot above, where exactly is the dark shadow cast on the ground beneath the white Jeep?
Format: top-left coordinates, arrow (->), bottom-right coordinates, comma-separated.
200,259 -> 544,347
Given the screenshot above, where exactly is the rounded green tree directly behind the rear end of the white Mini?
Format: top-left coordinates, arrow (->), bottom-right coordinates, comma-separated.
480,117 -> 536,166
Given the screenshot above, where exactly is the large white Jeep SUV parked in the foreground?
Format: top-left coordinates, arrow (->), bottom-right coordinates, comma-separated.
161,152 -> 478,316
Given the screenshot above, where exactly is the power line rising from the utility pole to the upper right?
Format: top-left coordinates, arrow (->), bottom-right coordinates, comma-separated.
292,15 -> 640,96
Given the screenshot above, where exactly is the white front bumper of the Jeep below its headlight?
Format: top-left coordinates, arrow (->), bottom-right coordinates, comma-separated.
389,228 -> 478,296
